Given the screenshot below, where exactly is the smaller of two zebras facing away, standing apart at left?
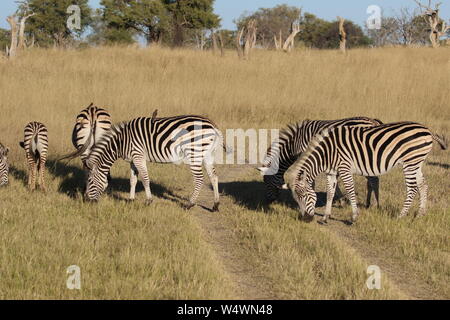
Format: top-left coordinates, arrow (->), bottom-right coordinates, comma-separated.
19,121 -> 48,192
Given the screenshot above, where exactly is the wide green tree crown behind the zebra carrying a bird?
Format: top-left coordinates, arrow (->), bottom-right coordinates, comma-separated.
97,0 -> 219,45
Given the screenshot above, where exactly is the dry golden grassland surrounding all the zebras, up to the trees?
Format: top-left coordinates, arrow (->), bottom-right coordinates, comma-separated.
0,48 -> 450,299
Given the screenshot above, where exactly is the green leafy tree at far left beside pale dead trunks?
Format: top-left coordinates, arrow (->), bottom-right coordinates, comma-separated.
19,0 -> 91,46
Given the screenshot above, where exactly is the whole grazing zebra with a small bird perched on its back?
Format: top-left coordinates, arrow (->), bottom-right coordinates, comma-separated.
85,115 -> 223,211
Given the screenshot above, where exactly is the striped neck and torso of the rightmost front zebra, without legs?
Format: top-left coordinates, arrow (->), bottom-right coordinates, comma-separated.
286,122 -> 442,186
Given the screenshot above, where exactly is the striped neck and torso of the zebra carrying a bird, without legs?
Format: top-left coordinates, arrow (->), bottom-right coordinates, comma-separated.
87,115 -> 223,168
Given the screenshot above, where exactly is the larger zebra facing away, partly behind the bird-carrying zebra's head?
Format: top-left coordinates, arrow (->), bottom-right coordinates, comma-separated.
59,103 -> 111,168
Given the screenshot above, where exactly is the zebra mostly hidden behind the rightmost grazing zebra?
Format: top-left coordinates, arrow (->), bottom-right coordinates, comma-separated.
258,117 -> 381,212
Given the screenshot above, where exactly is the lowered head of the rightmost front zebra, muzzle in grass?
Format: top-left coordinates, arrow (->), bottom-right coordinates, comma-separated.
290,171 -> 317,220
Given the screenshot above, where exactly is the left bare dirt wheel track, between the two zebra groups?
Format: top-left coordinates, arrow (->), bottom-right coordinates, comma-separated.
192,166 -> 276,300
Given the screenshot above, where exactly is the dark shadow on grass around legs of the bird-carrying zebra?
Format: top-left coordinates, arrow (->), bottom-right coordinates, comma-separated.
47,160 -> 185,204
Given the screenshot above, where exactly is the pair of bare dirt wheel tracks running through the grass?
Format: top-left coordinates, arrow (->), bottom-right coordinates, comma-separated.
192,166 -> 439,299
